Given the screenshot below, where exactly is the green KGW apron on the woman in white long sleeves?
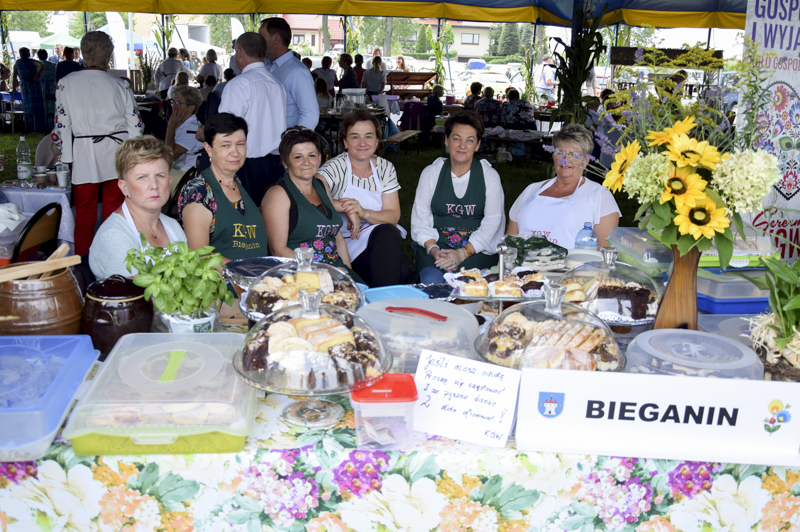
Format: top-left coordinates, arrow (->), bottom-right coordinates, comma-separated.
415,159 -> 497,271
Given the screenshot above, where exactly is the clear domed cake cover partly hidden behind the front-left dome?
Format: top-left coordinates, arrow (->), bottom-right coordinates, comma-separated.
239,248 -> 362,321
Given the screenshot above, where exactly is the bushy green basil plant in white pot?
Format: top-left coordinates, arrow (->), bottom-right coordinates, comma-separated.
125,234 -> 233,333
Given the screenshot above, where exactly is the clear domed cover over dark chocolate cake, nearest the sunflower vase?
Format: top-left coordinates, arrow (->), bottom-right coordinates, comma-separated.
558,247 -> 661,326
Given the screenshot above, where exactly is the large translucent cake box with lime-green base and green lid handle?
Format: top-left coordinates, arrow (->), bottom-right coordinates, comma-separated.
64,333 -> 256,456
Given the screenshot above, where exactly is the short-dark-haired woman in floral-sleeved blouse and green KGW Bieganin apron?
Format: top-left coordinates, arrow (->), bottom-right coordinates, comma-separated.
178,113 -> 269,262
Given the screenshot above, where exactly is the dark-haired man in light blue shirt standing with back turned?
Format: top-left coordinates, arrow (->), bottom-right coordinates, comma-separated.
258,17 -> 319,129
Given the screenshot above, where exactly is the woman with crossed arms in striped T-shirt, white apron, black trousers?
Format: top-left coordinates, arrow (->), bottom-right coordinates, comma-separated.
316,110 -> 411,287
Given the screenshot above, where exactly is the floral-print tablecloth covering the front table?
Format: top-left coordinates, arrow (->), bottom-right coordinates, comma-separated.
0,395 -> 800,532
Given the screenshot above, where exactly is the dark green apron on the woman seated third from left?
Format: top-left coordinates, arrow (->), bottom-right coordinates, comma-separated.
283,177 -> 344,268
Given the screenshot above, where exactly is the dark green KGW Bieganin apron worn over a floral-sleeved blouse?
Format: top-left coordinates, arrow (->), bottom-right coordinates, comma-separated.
200,168 -> 269,260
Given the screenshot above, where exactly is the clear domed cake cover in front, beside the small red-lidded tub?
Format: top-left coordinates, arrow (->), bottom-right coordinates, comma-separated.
234,290 -> 392,396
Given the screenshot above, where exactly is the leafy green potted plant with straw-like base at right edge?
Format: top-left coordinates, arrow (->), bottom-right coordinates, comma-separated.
746,257 -> 800,381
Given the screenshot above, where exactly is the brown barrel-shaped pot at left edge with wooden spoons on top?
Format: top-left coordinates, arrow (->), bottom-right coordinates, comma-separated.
0,263 -> 83,335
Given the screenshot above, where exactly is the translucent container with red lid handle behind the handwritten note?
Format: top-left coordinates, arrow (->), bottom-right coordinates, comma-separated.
358,298 -> 478,373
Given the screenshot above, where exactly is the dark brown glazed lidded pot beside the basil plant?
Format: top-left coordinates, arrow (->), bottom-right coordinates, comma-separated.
81,275 -> 153,360
